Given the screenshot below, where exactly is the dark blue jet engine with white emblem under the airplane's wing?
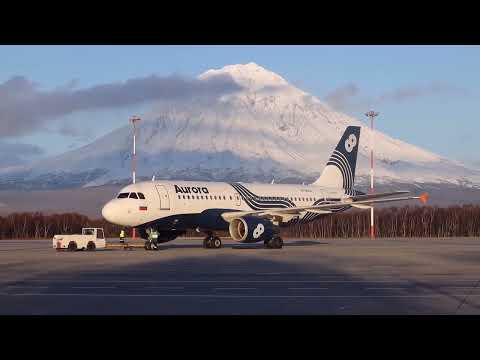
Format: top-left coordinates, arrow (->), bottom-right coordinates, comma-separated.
228,216 -> 275,243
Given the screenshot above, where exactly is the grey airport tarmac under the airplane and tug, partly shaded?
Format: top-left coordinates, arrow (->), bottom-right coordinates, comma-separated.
0,238 -> 480,315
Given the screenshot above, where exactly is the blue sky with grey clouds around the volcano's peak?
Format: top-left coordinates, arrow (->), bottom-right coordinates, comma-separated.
0,45 -> 480,167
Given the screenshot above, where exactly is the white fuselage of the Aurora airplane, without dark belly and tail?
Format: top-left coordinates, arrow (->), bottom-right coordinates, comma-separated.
102,181 -> 353,227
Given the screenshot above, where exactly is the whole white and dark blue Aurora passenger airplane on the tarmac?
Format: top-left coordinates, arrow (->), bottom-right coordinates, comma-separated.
102,126 -> 428,250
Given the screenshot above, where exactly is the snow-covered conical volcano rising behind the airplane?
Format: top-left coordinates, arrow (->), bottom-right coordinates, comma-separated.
0,63 -> 480,191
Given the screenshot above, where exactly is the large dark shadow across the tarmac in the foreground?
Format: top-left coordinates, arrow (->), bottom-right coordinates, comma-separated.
0,242 -> 461,315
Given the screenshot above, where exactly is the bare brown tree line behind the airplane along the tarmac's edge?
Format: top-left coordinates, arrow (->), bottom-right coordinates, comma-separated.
0,205 -> 480,239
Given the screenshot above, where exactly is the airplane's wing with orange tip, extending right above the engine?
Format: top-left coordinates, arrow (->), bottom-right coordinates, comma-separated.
221,192 -> 428,222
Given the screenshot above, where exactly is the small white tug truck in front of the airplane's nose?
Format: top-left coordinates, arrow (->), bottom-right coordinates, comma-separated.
53,228 -> 106,251
